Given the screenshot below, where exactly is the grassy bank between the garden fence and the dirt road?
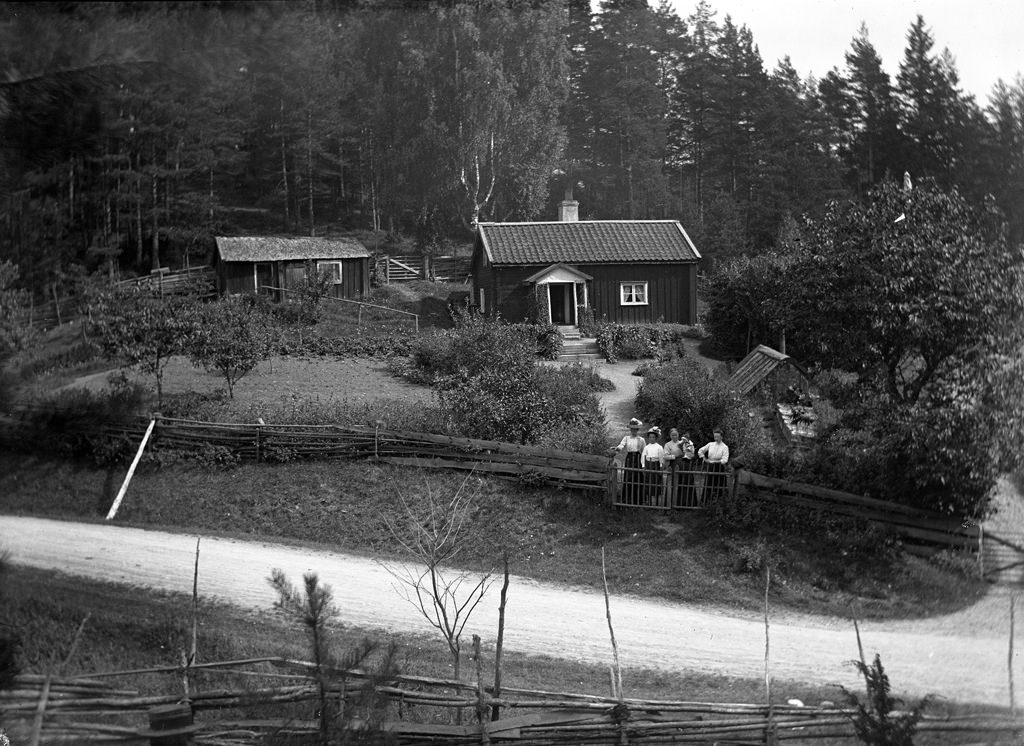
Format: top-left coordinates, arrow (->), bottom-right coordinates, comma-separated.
0,453 -> 984,619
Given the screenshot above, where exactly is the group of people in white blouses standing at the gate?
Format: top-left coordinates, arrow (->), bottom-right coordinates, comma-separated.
612,418 -> 729,508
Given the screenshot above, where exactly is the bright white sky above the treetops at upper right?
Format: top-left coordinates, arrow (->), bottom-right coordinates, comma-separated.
667,0 -> 1024,107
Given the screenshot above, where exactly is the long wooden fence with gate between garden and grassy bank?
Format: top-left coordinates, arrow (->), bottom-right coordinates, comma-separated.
0,415 -> 987,562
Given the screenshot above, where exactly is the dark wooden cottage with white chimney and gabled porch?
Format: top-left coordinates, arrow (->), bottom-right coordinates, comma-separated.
471,203 -> 700,326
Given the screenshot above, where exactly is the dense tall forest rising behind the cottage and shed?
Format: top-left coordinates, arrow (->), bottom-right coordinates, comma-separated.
0,0 -> 1024,294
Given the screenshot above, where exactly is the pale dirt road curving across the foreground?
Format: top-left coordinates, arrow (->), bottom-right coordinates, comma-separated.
6,516 -> 1024,705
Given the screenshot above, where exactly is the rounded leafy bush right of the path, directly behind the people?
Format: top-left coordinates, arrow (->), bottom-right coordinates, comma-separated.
636,357 -> 770,459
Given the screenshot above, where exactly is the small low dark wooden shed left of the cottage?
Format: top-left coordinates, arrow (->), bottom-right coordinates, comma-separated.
217,235 -> 370,298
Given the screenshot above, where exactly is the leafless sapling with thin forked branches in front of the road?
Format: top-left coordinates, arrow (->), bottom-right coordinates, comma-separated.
383,473 -> 494,679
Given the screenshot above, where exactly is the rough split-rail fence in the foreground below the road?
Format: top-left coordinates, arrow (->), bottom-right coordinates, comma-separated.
0,658 -> 1024,746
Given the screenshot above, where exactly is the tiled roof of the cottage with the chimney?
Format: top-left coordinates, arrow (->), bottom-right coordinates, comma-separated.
477,220 -> 700,265
